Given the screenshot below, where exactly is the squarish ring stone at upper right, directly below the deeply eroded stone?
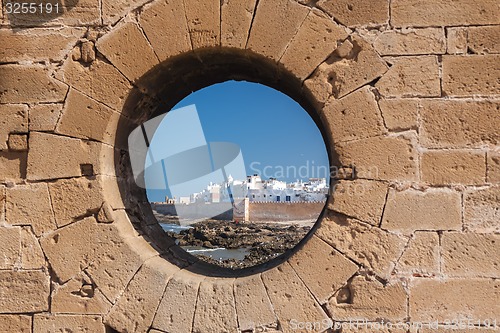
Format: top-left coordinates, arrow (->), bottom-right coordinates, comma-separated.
322,87 -> 384,143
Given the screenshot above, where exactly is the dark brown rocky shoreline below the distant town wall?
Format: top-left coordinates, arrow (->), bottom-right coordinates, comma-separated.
166,220 -> 311,269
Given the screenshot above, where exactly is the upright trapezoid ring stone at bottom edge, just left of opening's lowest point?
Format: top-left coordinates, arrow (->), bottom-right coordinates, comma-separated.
193,278 -> 238,333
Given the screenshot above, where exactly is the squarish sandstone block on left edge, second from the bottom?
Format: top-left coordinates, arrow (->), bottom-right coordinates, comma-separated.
0,271 -> 50,313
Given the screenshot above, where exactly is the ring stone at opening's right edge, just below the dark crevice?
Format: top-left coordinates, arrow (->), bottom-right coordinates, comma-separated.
328,179 -> 387,226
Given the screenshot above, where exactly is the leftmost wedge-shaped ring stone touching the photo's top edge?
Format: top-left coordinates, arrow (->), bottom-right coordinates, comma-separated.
139,0 -> 191,61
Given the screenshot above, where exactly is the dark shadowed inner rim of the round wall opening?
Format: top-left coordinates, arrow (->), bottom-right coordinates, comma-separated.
115,48 -> 338,276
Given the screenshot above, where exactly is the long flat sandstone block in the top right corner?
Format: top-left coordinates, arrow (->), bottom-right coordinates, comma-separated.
391,0 -> 500,27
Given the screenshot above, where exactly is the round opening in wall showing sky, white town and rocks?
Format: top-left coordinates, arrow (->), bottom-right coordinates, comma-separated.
129,81 -> 330,269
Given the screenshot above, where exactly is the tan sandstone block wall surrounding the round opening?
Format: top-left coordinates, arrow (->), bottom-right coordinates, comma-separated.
0,0 -> 500,333
